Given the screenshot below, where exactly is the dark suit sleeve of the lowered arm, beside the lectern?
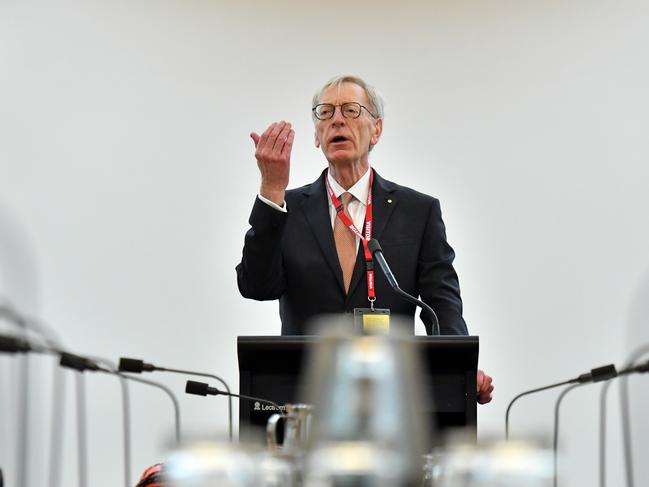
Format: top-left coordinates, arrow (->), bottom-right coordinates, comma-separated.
417,199 -> 468,335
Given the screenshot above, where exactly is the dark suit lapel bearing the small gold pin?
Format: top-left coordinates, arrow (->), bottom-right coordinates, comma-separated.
346,171 -> 397,302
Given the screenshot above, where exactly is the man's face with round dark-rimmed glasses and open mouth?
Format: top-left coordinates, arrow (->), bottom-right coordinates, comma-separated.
315,83 -> 382,165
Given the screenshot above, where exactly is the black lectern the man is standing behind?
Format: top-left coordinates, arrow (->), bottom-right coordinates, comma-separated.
237,335 -> 479,440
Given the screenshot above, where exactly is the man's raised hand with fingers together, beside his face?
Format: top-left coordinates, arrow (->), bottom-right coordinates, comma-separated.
250,120 -> 295,206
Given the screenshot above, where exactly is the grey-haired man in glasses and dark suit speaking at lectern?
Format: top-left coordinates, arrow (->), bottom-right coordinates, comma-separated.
237,76 -> 493,402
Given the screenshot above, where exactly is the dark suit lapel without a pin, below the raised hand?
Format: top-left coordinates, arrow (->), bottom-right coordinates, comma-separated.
301,172 -> 346,292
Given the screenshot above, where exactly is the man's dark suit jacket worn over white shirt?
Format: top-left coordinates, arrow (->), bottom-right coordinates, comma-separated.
237,171 -> 467,335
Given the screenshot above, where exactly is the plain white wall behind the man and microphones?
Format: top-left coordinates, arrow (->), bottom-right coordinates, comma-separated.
0,0 -> 649,486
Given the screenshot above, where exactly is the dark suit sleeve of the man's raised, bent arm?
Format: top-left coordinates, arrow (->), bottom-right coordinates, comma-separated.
236,198 -> 288,301
